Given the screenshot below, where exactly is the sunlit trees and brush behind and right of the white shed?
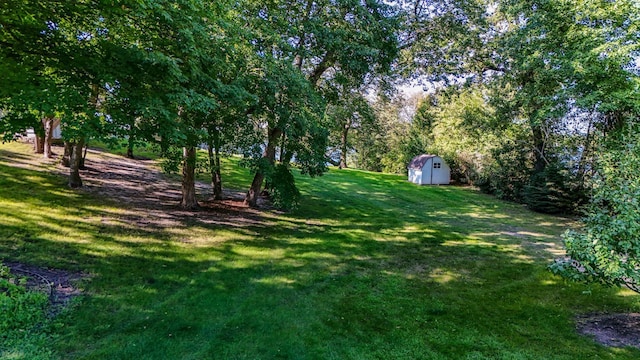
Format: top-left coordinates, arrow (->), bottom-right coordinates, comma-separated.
342,0 -> 640,213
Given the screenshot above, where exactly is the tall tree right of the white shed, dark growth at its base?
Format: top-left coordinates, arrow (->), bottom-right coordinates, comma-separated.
400,0 -> 640,212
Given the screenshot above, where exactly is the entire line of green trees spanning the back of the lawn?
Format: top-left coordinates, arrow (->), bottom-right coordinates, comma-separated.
0,0 -> 640,212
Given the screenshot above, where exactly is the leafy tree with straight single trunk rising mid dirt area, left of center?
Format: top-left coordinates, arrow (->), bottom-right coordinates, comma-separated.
101,0 -> 247,209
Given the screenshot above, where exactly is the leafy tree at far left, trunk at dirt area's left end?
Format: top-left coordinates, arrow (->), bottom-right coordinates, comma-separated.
0,1 -> 134,187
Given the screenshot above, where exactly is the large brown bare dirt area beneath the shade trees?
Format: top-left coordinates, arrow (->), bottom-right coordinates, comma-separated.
75,149 -> 271,229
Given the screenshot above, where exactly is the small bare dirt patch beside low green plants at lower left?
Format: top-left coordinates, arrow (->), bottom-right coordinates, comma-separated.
2,261 -> 87,315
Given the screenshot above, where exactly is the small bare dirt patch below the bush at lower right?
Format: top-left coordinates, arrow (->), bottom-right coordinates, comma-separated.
577,313 -> 640,349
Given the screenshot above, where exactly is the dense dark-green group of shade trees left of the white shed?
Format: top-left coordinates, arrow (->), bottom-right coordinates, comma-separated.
0,0 -> 399,208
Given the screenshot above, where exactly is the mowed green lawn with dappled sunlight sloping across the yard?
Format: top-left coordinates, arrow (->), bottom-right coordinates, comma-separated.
0,144 -> 640,359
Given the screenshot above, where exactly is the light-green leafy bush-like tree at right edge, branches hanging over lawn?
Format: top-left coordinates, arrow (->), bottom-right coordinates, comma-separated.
551,126 -> 640,293
